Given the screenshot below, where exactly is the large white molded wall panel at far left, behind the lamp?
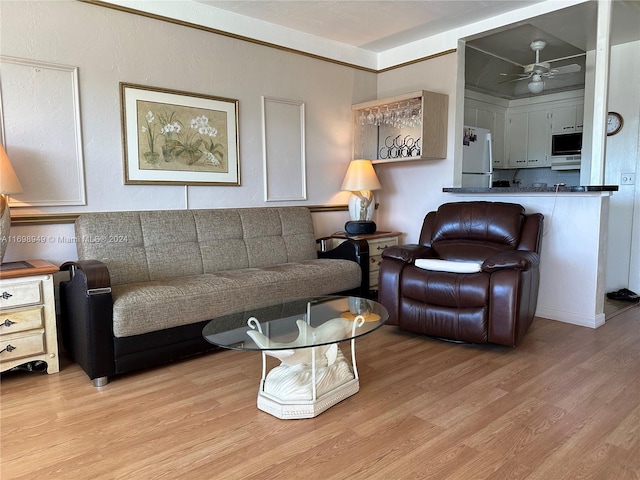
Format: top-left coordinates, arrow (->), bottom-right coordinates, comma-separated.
0,55 -> 87,208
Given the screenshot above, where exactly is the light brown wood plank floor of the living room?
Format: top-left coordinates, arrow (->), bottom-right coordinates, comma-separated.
0,308 -> 640,480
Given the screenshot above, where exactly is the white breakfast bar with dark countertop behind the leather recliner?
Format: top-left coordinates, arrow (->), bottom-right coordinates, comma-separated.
442,185 -> 618,328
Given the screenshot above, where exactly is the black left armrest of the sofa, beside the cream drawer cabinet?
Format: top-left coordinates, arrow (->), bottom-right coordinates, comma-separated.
60,260 -> 115,384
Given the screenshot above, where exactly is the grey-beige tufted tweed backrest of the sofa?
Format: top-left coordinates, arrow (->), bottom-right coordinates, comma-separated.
75,207 -> 317,285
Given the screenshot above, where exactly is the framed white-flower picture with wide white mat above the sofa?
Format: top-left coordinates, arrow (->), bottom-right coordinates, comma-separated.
120,83 -> 240,185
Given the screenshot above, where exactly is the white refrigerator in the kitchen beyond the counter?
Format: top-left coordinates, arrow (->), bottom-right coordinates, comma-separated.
462,126 -> 493,187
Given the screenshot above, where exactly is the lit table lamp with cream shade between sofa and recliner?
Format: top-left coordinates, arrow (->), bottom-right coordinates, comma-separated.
341,160 -> 382,235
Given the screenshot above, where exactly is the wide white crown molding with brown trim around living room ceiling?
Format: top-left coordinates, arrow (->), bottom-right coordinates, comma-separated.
79,0 -> 588,73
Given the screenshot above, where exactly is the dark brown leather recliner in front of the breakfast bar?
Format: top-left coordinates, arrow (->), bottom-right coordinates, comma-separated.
378,202 -> 543,346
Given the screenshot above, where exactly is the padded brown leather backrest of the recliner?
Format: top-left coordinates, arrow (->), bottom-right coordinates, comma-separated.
421,202 -> 525,262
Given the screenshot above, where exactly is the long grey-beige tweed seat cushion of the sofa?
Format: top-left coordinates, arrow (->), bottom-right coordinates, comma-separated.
112,259 -> 361,337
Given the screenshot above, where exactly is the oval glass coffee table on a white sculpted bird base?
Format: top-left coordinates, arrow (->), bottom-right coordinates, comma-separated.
202,296 -> 388,419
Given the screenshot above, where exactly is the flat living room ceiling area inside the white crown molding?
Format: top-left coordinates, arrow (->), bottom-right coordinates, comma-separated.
196,0 -> 541,53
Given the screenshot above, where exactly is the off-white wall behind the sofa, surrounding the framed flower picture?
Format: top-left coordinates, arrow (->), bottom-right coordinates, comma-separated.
0,0 -> 376,263
